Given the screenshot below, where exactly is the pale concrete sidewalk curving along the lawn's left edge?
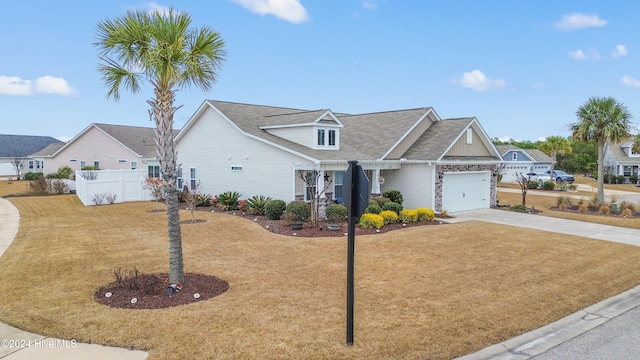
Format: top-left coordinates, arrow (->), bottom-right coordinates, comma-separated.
0,198 -> 149,360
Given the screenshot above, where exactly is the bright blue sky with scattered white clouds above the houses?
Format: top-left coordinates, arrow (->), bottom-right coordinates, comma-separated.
0,0 -> 640,141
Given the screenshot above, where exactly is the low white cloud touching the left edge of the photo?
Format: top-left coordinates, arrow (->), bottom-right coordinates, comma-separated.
0,75 -> 75,95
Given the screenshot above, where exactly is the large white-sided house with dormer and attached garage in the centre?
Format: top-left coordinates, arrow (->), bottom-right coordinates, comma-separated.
176,100 -> 502,212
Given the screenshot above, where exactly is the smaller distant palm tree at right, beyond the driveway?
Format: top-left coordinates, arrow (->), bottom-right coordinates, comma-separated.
569,97 -> 631,204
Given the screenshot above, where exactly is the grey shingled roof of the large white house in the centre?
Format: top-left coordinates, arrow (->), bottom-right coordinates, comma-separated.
176,100 -> 495,161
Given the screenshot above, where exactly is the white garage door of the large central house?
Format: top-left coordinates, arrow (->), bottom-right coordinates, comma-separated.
442,171 -> 491,213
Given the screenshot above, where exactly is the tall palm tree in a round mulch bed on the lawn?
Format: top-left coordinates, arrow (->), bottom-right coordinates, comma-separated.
94,9 -> 225,283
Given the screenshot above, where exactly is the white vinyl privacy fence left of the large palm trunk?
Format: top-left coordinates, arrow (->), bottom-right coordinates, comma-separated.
76,169 -> 153,206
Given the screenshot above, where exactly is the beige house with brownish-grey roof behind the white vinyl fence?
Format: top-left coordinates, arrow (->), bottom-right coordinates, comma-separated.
31,124 -> 177,177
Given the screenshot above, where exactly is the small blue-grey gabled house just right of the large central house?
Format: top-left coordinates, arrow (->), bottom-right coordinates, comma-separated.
496,144 -> 551,182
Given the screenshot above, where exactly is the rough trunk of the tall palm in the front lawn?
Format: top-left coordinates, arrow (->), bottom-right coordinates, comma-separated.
148,87 -> 184,283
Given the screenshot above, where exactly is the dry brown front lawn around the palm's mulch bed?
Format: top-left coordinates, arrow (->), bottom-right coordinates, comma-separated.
0,184 -> 640,359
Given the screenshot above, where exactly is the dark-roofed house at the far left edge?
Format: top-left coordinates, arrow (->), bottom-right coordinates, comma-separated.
0,135 -> 64,176
